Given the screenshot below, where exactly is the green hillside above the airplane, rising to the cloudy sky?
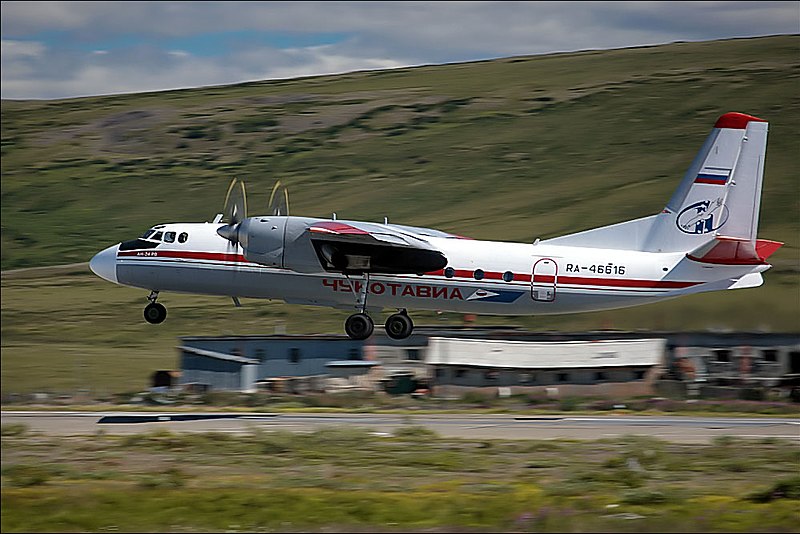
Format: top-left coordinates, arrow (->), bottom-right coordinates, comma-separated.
2,36 -> 800,270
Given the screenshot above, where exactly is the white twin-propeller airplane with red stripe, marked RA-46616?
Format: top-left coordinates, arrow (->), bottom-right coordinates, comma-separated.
90,113 -> 783,339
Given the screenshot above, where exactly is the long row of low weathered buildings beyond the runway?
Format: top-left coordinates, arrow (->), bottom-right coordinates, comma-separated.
178,326 -> 800,396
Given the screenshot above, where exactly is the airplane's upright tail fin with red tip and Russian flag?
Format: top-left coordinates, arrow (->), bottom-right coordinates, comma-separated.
642,113 -> 767,252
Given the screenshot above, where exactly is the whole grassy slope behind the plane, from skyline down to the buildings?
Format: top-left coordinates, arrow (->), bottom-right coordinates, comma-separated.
0,36 -> 800,392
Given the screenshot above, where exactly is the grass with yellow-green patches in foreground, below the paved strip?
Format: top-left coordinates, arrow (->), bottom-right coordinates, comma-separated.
1,425 -> 800,532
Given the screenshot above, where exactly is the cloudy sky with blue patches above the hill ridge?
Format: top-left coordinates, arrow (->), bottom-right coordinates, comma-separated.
0,1 -> 800,99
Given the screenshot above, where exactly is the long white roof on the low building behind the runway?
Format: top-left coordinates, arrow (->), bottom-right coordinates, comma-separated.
425,337 -> 666,369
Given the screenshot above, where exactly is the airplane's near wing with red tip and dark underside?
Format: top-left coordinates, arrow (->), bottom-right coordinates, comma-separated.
308,221 -> 447,274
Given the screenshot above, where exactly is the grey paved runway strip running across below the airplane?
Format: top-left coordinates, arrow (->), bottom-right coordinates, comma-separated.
0,411 -> 800,444
